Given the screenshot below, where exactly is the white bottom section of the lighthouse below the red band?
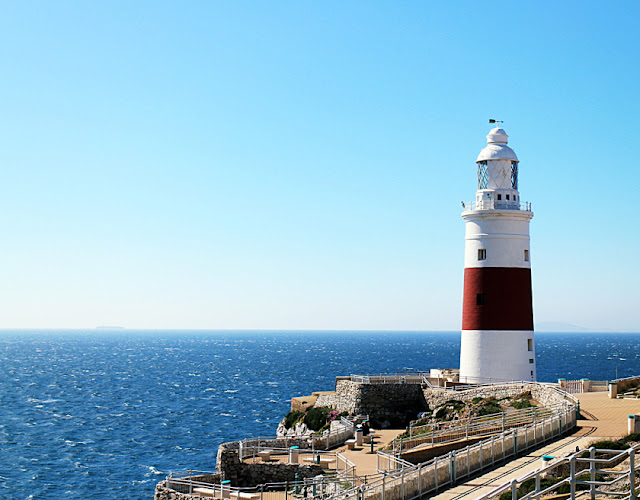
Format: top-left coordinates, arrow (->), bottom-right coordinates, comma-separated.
460,330 -> 536,383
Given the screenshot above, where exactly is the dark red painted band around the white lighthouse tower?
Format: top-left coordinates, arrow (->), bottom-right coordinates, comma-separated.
462,267 -> 533,330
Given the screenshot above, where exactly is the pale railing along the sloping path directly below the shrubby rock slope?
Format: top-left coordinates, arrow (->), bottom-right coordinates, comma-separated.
393,405 -> 564,456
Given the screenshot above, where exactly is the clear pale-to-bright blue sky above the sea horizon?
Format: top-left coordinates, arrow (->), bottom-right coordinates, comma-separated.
0,1 -> 640,331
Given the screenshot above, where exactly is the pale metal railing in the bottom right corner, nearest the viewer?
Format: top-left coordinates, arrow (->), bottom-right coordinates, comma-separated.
476,444 -> 640,500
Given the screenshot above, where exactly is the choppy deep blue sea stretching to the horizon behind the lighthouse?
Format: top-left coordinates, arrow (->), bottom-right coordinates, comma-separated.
0,331 -> 640,499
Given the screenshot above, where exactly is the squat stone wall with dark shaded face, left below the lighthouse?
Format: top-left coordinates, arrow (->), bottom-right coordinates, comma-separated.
316,379 -> 427,428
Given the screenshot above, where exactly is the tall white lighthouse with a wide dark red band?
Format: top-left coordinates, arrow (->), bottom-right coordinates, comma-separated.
460,127 -> 536,382
